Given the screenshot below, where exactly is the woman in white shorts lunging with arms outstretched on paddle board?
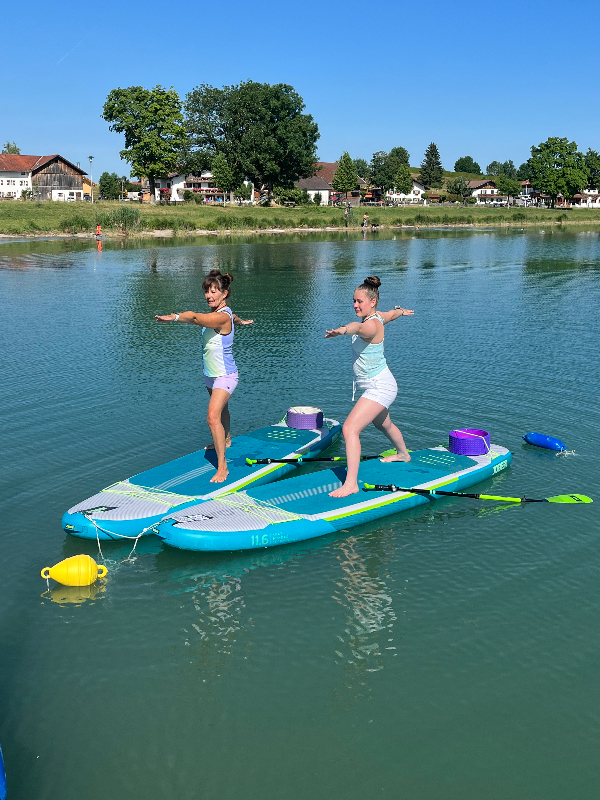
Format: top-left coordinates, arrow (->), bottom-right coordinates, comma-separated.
325,276 -> 415,497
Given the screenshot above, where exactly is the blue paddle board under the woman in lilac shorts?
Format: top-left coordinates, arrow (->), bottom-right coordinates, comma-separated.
62,419 -> 342,540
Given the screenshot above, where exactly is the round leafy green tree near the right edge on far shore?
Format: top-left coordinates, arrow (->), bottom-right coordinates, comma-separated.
529,136 -> 589,208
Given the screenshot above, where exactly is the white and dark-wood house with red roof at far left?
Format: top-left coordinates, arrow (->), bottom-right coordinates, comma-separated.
0,153 -> 86,201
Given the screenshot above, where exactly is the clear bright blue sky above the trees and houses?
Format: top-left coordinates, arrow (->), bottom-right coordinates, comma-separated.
0,0 -> 600,178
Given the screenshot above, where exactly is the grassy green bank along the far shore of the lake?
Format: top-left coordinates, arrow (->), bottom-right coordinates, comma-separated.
0,202 -> 600,236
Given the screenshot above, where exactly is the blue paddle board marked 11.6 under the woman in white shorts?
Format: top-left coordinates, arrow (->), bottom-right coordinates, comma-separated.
156,445 -> 512,550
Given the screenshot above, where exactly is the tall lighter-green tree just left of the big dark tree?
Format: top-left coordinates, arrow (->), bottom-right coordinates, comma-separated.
102,86 -> 185,199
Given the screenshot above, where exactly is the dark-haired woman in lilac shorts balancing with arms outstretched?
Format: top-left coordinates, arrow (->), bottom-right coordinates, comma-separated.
156,269 -> 253,483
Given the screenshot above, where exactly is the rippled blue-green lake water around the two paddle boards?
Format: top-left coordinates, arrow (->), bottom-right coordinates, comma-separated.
0,230 -> 600,800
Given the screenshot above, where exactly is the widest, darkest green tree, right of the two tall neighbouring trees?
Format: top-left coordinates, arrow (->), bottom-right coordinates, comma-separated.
184,81 -> 319,195
